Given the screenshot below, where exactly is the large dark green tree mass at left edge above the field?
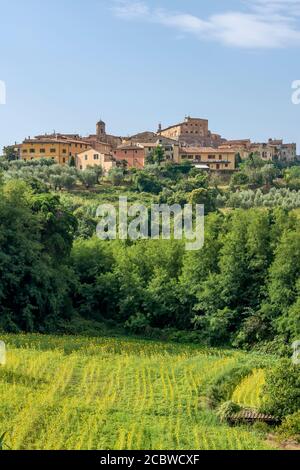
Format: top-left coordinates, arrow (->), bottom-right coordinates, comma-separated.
0,180 -> 76,331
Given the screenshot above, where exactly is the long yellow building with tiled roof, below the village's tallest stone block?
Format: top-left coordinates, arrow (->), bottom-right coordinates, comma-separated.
180,147 -> 236,171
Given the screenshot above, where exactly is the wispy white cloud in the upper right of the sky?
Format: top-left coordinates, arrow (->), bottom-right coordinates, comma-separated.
113,0 -> 300,49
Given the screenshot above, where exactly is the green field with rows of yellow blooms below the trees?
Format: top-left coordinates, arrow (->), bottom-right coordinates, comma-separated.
0,335 -> 274,450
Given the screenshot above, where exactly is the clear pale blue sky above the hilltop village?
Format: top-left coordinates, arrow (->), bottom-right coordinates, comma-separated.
0,0 -> 300,153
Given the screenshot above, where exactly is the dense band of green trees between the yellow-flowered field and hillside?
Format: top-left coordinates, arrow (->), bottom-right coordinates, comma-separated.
0,175 -> 300,347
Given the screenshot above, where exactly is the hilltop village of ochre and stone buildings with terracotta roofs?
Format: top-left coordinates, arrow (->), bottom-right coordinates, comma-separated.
15,116 -> 297,173
